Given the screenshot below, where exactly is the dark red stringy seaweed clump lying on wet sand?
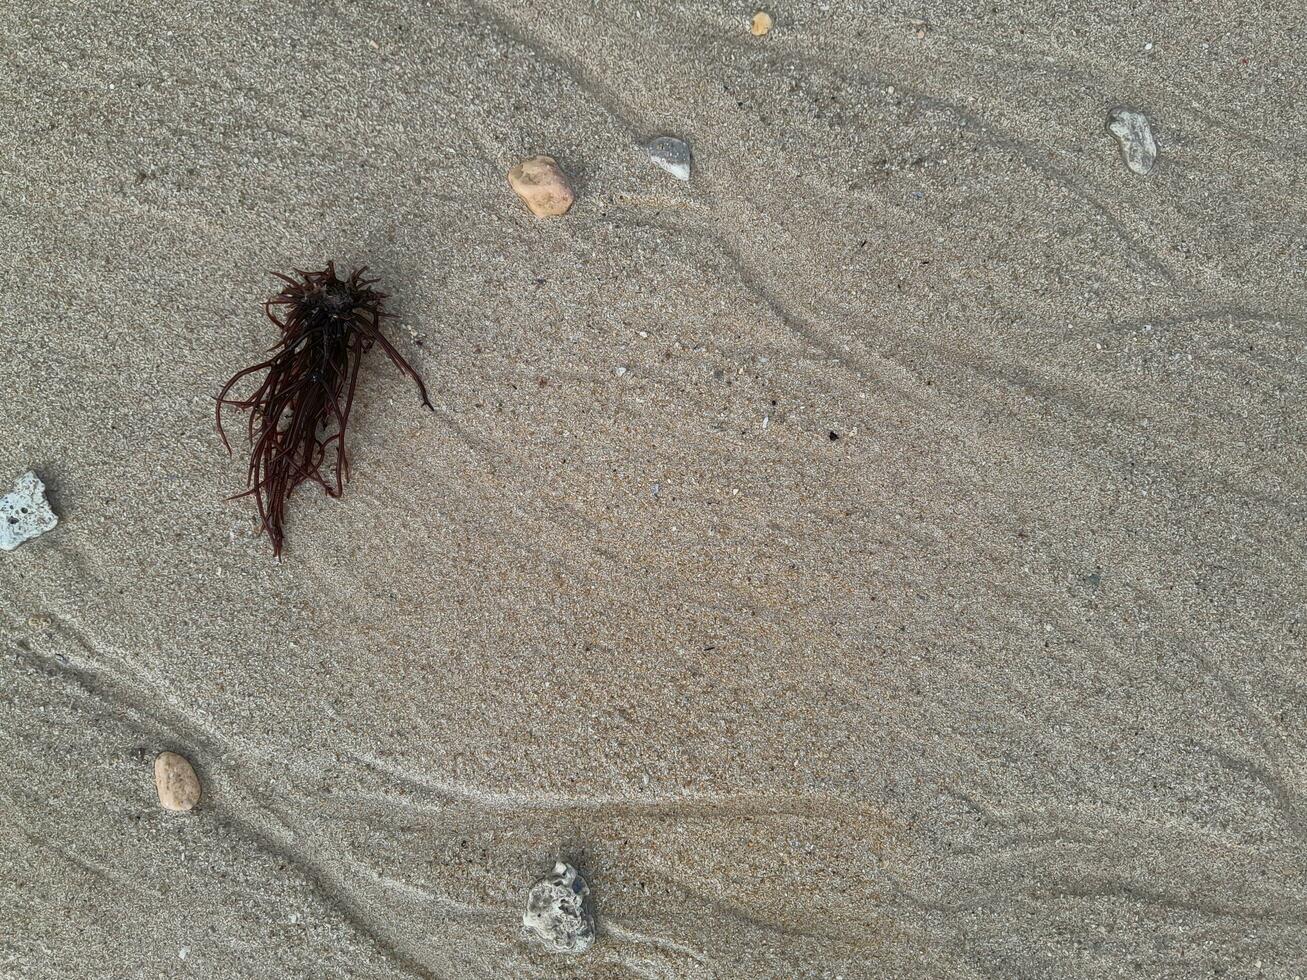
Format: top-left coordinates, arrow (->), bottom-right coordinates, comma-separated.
214,263 -> 434,557
